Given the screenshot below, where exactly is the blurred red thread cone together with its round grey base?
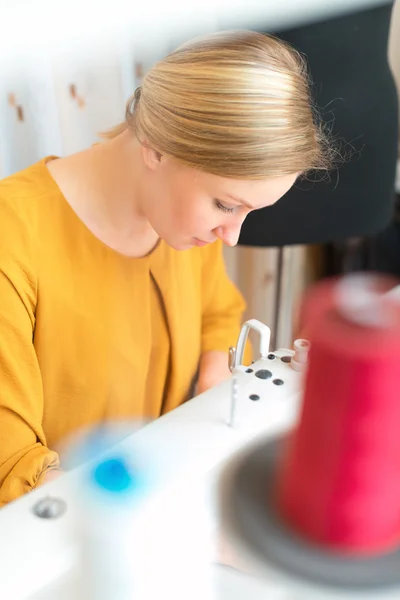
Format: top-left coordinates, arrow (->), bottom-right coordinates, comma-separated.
226,274 -> 400,598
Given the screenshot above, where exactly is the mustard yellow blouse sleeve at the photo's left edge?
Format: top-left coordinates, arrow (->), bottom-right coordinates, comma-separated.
0,199 -> 59,506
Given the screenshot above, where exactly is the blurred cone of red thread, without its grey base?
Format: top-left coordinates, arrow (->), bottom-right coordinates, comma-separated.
276,276 -> 400,555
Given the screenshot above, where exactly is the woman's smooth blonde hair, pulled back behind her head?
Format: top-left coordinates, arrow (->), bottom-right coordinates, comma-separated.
104,31 -> 331,179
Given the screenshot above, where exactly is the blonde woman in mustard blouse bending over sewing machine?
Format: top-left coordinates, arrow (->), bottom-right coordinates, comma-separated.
0,32 -> 327,504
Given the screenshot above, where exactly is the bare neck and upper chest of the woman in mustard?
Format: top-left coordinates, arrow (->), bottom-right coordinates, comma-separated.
49,131 -> 158,256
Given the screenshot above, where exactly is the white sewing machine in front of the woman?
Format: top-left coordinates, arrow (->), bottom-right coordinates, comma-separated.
0,276 -> 400,600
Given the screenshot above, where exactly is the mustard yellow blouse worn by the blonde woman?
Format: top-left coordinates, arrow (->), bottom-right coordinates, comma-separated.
0,158 -> 244,505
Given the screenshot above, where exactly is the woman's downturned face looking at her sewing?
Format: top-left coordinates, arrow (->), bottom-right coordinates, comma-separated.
142,148 -> 298,250
